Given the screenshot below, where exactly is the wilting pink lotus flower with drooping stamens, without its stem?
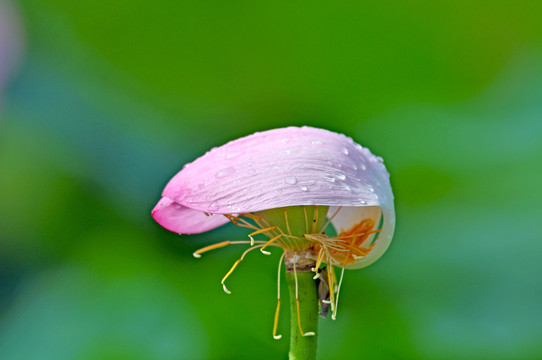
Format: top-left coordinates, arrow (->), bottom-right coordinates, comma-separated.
152,127 -> 395,335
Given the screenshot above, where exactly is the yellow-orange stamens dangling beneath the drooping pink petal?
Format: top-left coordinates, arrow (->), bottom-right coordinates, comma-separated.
194,205 -> 381,339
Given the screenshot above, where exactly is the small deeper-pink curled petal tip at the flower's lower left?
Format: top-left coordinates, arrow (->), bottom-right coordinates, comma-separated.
152,197 -> 229,234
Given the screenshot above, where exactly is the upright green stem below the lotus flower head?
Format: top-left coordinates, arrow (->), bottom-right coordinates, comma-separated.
286,272 -> 318,360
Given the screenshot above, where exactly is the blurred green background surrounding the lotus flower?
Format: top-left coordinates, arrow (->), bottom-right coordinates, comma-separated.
0,0 -> 542,360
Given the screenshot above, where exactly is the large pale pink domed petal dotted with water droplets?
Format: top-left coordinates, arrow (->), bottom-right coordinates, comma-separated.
155,127 -> 393,239
